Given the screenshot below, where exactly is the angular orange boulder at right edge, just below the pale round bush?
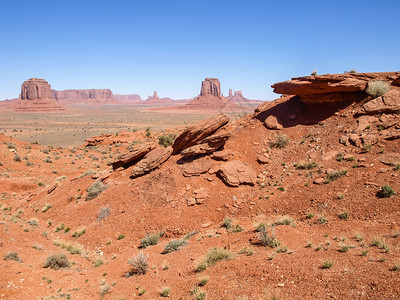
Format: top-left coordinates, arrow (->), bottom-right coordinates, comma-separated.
359,89 -> 400,114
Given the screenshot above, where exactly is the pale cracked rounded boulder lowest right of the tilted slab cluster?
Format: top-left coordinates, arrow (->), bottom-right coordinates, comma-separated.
218,160 -> 257,186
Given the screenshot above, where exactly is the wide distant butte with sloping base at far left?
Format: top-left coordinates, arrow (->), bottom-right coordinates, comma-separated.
10,78 -> 65,112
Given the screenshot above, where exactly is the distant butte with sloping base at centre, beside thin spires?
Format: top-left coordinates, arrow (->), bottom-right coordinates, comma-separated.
185,78 -> 240,110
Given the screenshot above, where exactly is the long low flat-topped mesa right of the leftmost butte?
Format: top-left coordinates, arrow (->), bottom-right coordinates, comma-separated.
51,89 -> 117,105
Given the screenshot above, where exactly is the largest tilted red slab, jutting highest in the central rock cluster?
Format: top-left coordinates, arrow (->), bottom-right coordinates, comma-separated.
172,114 -> 229,154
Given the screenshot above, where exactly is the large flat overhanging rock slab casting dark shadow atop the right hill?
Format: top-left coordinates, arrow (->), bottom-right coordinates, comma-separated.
272,72 -> 400,103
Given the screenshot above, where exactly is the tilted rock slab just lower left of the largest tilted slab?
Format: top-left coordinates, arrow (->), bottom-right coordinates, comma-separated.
131,147 -> 172,178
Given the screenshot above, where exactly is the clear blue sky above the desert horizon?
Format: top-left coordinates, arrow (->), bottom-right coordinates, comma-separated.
0,0 -> 400,100
